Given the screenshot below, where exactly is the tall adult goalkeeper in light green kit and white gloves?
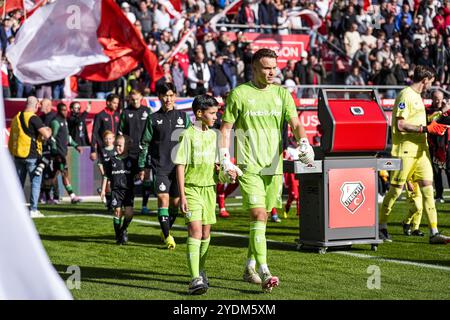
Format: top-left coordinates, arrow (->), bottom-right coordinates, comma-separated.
219,48 -> 314,292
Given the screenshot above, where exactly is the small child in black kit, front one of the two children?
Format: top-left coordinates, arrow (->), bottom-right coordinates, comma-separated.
101,136 -> 137,244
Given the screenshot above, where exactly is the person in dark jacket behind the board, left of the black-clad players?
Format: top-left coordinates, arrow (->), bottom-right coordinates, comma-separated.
67,101 -> 91,147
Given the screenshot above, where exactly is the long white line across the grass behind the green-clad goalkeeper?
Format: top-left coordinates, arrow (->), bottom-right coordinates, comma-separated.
40,213 -> 450,271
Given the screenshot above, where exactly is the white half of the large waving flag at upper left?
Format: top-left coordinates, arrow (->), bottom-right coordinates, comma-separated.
6,0 -> 110,84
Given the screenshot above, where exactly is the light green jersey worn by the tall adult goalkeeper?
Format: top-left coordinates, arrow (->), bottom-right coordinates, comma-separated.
222,82 -> 298,175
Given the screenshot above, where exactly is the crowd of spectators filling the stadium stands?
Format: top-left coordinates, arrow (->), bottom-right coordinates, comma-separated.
0,0 -> 450,99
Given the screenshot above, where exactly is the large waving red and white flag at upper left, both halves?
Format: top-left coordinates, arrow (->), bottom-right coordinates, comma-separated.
6,0 -> 163,84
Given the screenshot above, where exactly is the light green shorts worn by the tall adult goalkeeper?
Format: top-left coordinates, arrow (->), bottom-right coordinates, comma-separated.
239,172 -> 283,212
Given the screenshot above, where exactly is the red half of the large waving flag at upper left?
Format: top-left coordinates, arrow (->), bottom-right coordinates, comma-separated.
80,0 -> 163,82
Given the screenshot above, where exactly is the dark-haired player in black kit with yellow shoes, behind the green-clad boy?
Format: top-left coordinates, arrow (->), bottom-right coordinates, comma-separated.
139,83 -> 190,249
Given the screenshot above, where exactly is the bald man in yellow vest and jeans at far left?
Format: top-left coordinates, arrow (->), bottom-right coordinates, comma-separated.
8,96 -> 51,218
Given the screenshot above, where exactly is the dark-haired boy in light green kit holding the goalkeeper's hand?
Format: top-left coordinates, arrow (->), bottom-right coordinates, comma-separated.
174,94 -> 236,294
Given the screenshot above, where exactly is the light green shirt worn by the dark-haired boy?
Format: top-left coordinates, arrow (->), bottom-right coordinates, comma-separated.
174,125 -> 217,187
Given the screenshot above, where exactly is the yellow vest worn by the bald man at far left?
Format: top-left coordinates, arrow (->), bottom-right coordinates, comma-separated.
8,111 -> 42,158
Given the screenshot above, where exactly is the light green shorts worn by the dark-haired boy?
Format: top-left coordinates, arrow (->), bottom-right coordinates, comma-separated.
184,185 -> 216,225
